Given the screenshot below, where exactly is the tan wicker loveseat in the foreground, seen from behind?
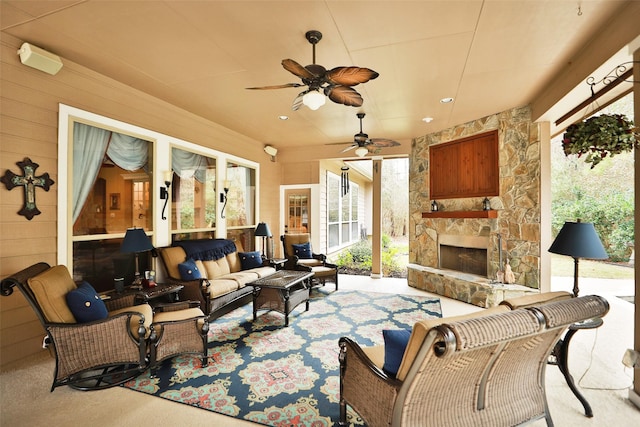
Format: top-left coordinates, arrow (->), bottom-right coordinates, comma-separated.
339,292 -> 609,427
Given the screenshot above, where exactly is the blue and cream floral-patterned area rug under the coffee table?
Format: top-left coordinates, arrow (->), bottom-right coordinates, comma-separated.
124,288 -> 442,427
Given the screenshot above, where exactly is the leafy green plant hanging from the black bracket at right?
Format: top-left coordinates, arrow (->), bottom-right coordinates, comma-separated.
562,114 -> 640,169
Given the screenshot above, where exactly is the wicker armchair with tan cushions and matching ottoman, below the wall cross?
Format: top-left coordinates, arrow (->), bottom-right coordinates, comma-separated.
1,263 -> 208,391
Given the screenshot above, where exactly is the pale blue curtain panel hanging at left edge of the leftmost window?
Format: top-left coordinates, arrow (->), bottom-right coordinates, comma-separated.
72,122 -> 111,223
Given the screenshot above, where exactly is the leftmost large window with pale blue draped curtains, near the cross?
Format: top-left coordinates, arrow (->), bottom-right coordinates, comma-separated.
71,122 -> 153,290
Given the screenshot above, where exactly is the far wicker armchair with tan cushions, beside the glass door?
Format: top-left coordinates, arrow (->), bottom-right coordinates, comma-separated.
280,233 -> 338,291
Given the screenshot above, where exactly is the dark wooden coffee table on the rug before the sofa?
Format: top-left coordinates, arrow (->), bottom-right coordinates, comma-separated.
247,270 -> 313,326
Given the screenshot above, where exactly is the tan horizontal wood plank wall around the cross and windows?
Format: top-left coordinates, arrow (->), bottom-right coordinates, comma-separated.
0,34 -> 280,366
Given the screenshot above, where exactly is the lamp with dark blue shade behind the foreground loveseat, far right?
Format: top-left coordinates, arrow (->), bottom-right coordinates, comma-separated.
549,220 -> 609,297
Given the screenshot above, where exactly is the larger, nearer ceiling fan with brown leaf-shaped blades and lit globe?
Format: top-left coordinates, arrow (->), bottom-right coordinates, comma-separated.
247,30 -> 379,111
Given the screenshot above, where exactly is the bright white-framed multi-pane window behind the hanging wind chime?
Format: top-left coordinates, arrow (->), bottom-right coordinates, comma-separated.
327,172 -> 360,250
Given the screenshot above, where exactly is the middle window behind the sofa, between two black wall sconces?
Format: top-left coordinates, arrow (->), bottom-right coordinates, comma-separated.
169,147 -> 217,240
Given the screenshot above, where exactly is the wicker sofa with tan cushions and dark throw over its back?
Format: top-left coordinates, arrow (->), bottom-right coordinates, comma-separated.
158,239 -> 276,318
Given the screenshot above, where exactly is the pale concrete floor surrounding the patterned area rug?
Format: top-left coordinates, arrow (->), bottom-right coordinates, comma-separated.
0,275 -> 640,427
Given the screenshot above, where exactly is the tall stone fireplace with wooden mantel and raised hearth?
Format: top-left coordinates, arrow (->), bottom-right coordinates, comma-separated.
407,107 -> 540,307
